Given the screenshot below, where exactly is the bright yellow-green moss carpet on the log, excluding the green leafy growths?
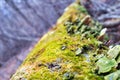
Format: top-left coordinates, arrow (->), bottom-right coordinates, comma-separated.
11,3 -> 109,80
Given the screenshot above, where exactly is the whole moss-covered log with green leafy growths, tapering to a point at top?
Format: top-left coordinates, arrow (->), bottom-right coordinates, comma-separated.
11,3 -> 120,80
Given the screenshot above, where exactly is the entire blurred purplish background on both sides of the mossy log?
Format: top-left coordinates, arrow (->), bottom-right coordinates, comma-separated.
0,0 -> 120,80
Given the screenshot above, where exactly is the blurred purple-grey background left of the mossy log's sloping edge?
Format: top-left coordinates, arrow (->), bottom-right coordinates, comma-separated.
0,0 -> 74,80
